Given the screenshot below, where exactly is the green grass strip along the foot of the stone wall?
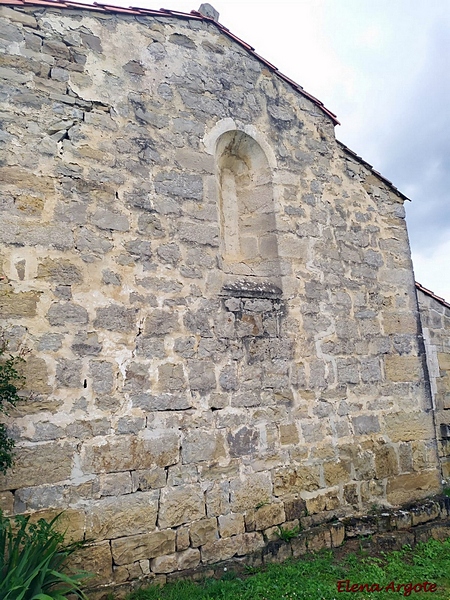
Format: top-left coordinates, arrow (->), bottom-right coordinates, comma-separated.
127,538 -> 450,600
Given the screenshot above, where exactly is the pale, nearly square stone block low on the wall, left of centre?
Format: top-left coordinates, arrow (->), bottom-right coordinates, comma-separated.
158,484 -> 206,528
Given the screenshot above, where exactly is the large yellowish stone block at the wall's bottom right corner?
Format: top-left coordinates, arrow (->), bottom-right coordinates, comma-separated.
386,470 -> 442,506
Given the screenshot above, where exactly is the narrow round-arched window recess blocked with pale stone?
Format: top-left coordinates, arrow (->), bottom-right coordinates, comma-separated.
216,130 -> 280,278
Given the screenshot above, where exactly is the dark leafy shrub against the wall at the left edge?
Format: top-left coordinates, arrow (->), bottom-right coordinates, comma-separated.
0,333 -> 27,474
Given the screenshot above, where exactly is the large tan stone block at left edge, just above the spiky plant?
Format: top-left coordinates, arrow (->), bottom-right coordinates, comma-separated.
0,442 -> 75,491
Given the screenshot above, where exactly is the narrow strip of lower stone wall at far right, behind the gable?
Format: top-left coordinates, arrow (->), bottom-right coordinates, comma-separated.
417,286 -> 450,483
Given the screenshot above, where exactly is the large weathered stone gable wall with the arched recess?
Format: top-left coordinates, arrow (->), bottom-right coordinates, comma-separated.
0,7 -> 440,596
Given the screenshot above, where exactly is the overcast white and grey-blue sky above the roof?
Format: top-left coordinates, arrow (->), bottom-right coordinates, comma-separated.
96,0 -> 450,300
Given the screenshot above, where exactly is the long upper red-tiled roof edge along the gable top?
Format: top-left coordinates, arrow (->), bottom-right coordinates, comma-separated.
0,0 -> 340,125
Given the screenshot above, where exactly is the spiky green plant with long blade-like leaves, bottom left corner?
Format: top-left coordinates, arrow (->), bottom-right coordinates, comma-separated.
0,510 -> 87,600
